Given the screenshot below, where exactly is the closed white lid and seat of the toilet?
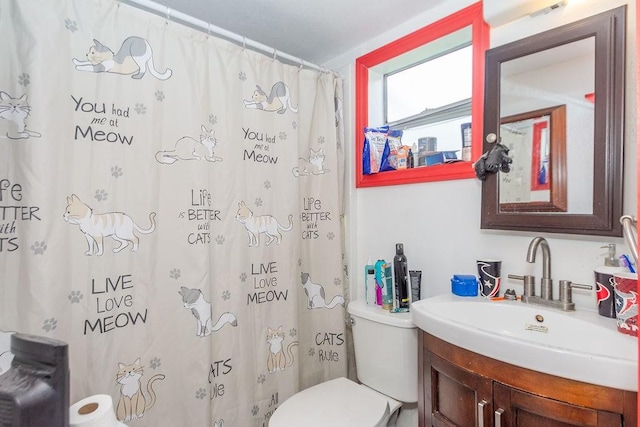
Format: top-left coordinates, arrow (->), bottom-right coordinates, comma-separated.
269,378 -> 400,427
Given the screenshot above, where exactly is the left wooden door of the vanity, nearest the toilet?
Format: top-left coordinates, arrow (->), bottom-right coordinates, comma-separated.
423,350 -> 492,427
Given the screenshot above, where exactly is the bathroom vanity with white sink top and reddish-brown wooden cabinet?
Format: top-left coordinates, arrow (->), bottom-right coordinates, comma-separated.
411,294 -> 638,427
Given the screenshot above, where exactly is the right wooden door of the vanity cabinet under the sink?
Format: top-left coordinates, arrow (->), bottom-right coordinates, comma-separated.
493,382 -> 623,427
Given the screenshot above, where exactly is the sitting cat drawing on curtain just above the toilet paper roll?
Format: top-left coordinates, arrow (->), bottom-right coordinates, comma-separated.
116,358 -> 165,422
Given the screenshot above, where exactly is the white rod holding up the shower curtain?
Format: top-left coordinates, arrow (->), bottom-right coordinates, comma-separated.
118,0 -> 330,73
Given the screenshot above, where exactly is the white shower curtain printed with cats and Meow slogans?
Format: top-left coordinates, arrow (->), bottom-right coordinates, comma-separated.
0,0 -> 348,427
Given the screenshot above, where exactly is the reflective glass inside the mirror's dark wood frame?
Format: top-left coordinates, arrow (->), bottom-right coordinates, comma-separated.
498,37 -> 595,214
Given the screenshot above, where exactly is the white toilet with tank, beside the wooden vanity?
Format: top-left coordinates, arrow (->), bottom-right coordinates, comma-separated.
269,301 -> 418,427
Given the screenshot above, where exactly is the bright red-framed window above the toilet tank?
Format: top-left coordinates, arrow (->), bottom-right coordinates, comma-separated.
356,3 -> 488,187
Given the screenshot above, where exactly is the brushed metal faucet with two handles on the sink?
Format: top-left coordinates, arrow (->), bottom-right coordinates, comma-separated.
509,237 -> 592,311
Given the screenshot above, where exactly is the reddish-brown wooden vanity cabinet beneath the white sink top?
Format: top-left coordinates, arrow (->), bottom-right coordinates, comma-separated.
418,332 -> 637,427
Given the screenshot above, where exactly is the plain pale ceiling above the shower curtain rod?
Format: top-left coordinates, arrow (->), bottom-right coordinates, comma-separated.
134,0 -> 445,65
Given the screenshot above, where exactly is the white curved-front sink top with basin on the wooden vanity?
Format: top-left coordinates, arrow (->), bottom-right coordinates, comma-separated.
411,294 -> 638,391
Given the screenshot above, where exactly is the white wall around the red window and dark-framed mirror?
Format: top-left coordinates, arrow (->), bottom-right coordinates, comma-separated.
325,0 -> 637,309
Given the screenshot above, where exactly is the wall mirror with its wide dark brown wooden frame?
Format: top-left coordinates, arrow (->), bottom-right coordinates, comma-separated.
481,6 -> 626,236
